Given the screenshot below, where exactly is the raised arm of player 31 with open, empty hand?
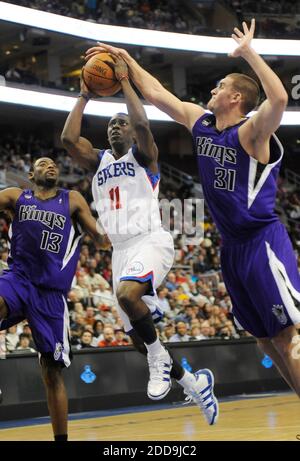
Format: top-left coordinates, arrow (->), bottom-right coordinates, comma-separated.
231,19 -> 288,163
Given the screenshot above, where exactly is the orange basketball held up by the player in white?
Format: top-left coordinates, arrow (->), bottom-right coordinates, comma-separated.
82,53 -> 121,96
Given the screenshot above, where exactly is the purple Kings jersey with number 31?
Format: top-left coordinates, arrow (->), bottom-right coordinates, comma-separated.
192,114 -> 283,242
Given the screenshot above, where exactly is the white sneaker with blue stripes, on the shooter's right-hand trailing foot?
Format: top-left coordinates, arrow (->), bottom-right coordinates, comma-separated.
184,368 -> 219,426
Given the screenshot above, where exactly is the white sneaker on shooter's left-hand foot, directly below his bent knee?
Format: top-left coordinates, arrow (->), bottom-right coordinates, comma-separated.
147,349 -> 173,400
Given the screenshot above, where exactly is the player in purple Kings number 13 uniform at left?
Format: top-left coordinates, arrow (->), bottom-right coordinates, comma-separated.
0,157 -> 107,441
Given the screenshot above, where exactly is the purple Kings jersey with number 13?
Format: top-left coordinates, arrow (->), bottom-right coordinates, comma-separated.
8,189 -> 81,292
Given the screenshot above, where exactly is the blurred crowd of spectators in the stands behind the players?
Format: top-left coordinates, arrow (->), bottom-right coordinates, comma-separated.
0,0 -> 300,353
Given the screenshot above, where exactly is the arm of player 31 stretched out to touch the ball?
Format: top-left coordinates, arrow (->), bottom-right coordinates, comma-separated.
86,42 -> 204,130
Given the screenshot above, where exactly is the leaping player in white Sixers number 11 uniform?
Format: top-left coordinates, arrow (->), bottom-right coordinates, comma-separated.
61,54 -> 218,424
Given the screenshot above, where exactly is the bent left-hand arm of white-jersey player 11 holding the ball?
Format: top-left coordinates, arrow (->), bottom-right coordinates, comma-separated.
61,79 -> 99,170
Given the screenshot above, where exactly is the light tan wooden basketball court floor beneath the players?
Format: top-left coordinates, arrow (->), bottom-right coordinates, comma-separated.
0,392 -> 300,442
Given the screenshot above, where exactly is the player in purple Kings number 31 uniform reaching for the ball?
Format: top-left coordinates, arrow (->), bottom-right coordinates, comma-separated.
87,19 -> 300,396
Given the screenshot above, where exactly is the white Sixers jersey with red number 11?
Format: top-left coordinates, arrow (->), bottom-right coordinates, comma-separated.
92,145 -> 163,245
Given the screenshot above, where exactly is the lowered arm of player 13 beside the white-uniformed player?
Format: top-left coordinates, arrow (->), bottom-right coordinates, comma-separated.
70,190 -> 111,250
